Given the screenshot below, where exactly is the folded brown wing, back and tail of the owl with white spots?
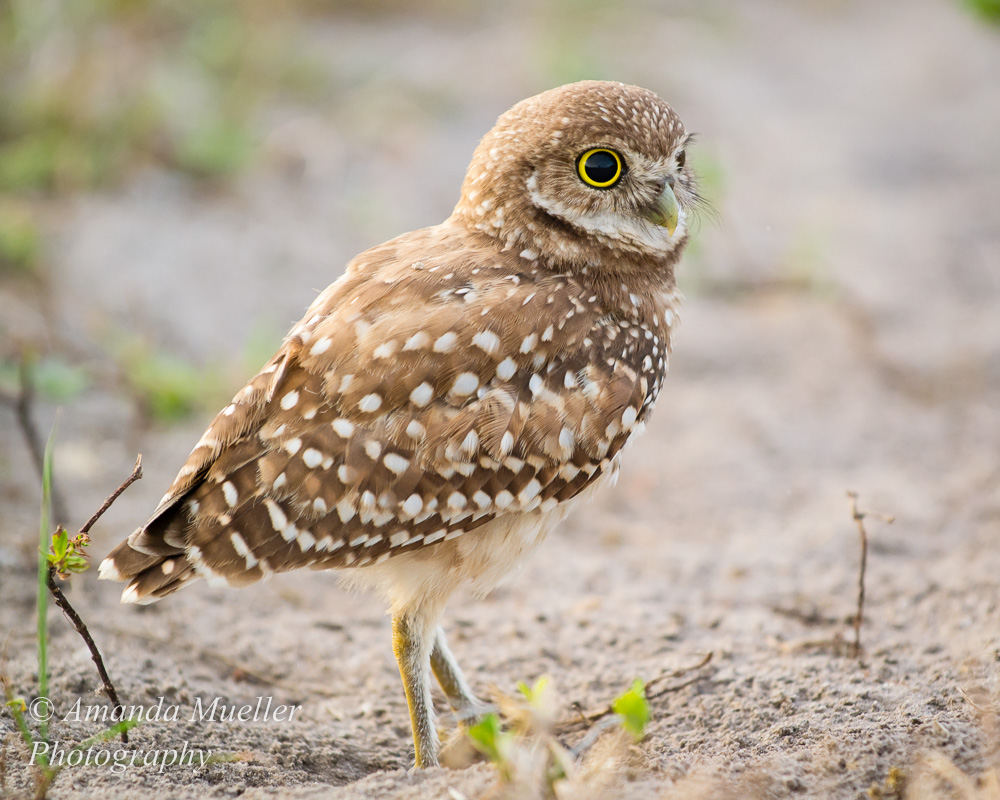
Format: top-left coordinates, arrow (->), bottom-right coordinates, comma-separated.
101,229 -> 666,602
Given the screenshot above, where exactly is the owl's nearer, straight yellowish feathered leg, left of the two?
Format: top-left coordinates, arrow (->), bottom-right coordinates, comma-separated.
392,613 -> 440,769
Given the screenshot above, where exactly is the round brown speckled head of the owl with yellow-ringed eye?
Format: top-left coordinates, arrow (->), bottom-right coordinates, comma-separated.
455,81 -> 697,266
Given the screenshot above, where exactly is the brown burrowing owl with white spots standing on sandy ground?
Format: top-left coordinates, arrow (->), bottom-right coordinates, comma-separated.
101,81 -> 697,766
